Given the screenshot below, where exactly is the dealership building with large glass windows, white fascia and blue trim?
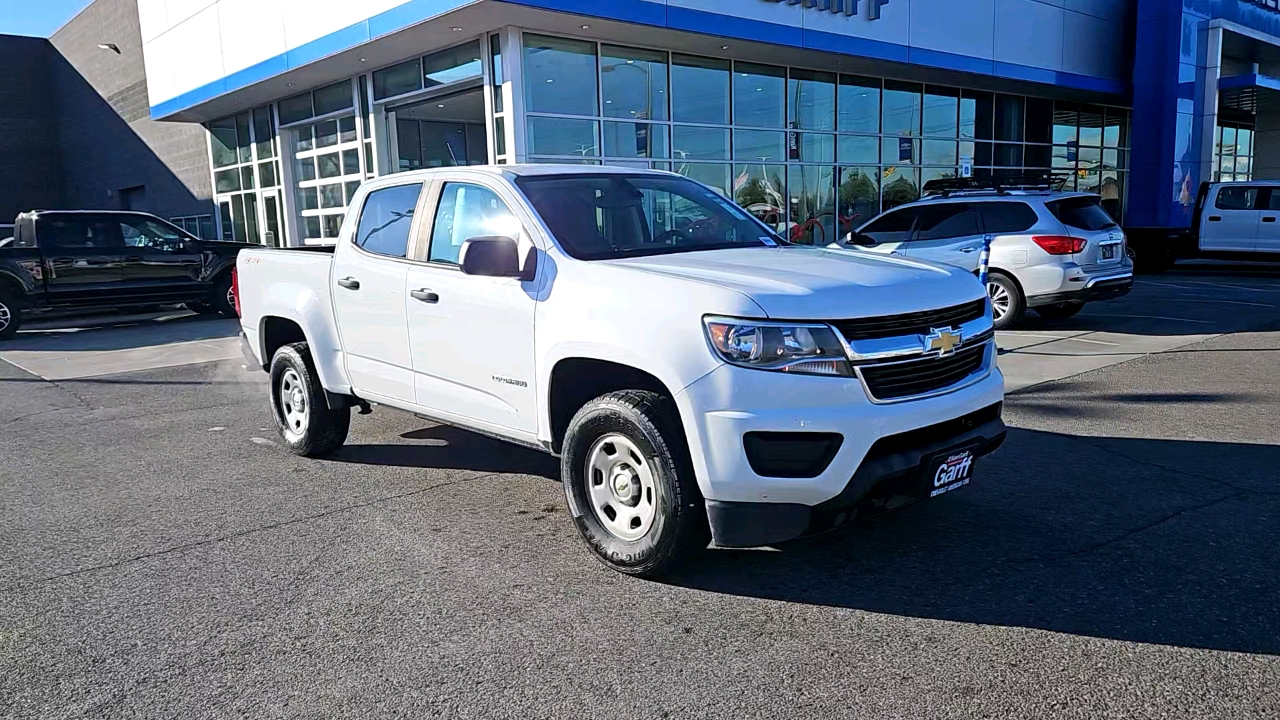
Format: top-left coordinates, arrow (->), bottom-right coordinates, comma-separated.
7,0 -> 1280,245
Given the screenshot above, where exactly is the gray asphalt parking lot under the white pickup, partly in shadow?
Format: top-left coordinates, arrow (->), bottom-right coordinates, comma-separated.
0,265 -> 1280,719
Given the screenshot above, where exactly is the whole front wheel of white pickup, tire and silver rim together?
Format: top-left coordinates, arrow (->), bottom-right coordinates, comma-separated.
561,391 -> 710,578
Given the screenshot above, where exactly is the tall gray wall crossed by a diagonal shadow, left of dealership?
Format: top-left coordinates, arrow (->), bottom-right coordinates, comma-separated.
50,0 -> 212,217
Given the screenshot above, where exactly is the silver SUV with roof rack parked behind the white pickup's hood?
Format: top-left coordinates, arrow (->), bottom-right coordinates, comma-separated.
846,182 -> 1133,329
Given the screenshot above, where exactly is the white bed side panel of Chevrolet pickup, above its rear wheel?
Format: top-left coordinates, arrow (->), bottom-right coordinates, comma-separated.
237,249 -> 351,393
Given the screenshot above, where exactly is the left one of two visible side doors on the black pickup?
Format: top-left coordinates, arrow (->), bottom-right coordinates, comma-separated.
36,213 -> 125,305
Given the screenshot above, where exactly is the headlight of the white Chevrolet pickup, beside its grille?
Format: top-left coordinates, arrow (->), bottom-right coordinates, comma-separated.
705,318 -> 854,377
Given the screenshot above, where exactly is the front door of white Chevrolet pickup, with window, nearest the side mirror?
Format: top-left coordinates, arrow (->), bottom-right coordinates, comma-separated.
406,176 -> 538,433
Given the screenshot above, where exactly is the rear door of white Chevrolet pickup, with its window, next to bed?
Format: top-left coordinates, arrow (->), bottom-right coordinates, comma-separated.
332,182 -> 422,404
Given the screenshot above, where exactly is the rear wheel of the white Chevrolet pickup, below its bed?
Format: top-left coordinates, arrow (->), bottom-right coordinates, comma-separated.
271,342 -> 351,457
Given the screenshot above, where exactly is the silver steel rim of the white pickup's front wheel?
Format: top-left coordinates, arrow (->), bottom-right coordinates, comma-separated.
586,433 -> 658,542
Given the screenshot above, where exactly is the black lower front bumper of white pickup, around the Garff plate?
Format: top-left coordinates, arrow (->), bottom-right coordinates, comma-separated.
707,404 -> 1006,547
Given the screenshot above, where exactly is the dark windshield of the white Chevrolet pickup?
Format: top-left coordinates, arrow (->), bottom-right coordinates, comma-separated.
516,174 -> 786,260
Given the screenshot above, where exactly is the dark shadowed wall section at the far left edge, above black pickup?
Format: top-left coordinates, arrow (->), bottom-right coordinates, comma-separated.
0,36 -> 64,224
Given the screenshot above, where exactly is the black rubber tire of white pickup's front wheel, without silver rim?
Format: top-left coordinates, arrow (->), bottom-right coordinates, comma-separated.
561,391 -> 710,578
